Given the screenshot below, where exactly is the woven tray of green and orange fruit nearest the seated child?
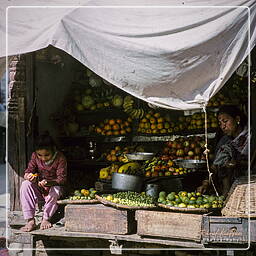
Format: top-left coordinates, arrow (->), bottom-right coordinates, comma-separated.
57,188 -> 98,204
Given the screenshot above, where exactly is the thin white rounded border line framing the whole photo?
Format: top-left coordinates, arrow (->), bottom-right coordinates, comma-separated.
6,5 -> 251,251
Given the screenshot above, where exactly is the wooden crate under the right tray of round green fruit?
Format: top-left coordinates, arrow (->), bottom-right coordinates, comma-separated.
135,210 -> 203,241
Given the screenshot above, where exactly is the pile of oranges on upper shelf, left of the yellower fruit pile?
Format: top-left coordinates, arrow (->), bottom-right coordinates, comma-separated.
95,118 -> 132,136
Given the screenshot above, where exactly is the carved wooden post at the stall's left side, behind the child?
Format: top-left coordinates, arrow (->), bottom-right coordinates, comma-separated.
7,55 -> 33,211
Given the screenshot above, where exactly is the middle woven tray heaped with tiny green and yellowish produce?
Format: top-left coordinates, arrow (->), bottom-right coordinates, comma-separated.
96,191 -> 156,209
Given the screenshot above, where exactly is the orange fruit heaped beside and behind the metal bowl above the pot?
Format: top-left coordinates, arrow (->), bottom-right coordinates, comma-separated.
102,146 -> 145,163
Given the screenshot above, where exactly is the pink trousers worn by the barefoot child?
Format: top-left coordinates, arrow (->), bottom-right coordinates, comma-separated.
20,180 -> 62,220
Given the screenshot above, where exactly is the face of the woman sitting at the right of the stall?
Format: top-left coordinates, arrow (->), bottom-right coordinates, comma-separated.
218,113 -> 238,136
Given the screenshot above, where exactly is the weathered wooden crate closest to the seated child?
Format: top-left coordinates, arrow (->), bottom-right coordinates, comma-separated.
65,204 -> 136,235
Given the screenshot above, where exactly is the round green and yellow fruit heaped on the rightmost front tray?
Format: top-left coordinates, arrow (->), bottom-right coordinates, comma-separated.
158,191 -> 224,209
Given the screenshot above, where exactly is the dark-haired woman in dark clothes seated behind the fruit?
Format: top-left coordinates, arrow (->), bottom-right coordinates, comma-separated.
197,105 -> 248,196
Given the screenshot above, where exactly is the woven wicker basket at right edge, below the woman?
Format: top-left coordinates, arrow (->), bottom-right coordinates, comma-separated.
221,175 -> 256,218
